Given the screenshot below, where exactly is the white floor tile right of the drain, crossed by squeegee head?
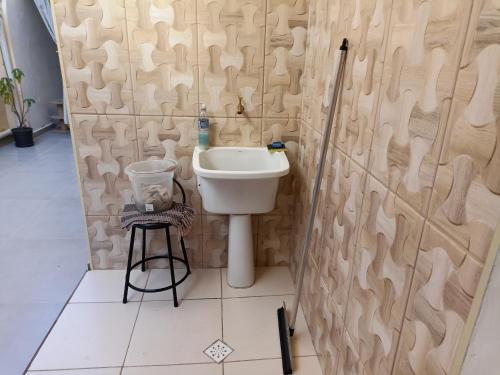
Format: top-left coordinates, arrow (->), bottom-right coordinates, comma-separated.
222,296 -> 316,362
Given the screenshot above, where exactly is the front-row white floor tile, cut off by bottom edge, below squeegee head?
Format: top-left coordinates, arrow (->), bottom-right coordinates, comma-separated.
224,356 -> 322,375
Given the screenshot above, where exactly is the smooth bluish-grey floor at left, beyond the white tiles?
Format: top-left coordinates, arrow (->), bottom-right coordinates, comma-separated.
0,130 -> 88,375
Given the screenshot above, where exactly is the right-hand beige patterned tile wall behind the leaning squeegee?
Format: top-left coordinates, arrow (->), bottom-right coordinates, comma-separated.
290,0 -> 500,375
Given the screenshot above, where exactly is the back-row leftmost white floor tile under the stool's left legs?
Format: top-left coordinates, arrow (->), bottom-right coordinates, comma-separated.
70,270 -> 149,303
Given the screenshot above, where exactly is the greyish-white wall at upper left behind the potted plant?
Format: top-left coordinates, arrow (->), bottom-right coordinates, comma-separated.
3,0 -> 63,130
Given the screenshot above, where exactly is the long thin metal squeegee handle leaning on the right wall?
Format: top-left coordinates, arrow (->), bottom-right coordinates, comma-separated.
290,39 -> 348,334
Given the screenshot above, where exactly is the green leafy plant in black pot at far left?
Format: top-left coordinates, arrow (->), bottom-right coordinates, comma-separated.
0,68 -> 35,147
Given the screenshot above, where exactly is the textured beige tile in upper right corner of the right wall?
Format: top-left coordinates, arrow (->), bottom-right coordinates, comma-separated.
430,1 -> 500,261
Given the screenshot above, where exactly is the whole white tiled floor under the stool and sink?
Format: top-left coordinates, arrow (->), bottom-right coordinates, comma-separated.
28,267 -> 321,375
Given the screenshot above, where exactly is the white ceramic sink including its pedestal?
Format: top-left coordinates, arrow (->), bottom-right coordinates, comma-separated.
193,147 -> 290,288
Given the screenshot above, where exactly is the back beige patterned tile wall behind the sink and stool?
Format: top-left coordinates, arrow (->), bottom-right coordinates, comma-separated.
53,0 -> 309,269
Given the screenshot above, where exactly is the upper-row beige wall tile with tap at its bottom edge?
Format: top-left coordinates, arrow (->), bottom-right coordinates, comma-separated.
198,0 -> 266,117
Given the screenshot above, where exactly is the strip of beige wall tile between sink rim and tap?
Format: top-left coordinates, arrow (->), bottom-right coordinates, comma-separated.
210,117 -> 262,147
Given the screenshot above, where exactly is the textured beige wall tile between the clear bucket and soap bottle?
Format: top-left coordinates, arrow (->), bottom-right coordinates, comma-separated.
137,116 -> 201,213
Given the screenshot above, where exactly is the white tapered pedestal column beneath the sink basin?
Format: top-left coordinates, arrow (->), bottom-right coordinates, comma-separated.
227,215 -> 255,288
